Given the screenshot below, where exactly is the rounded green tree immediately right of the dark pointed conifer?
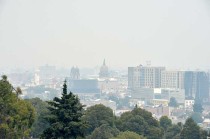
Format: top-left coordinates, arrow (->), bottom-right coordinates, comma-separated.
83,104 -> 114,134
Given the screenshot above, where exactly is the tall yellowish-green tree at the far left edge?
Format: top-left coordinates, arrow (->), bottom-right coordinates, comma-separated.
0,75 -> 35,139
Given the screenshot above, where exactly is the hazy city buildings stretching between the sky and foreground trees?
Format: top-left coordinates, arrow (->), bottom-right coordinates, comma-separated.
2,59 -> 210,128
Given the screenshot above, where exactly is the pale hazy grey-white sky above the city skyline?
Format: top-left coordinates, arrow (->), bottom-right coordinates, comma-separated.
0,0 -> 210,69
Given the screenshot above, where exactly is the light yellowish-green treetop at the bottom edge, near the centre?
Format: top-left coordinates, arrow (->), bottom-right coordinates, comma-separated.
111,131 -> 146,139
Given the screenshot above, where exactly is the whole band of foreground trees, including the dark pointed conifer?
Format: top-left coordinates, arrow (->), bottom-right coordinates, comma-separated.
0,76 -> 207,139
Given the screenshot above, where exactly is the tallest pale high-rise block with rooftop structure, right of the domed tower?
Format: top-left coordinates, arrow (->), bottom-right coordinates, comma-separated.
128,65 -> 165,90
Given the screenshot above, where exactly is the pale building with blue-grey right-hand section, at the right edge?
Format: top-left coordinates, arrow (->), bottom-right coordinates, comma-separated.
161,71 -> 209,101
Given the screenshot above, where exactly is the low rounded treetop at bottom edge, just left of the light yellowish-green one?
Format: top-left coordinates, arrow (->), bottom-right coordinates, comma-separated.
87,124 -> 120,139
